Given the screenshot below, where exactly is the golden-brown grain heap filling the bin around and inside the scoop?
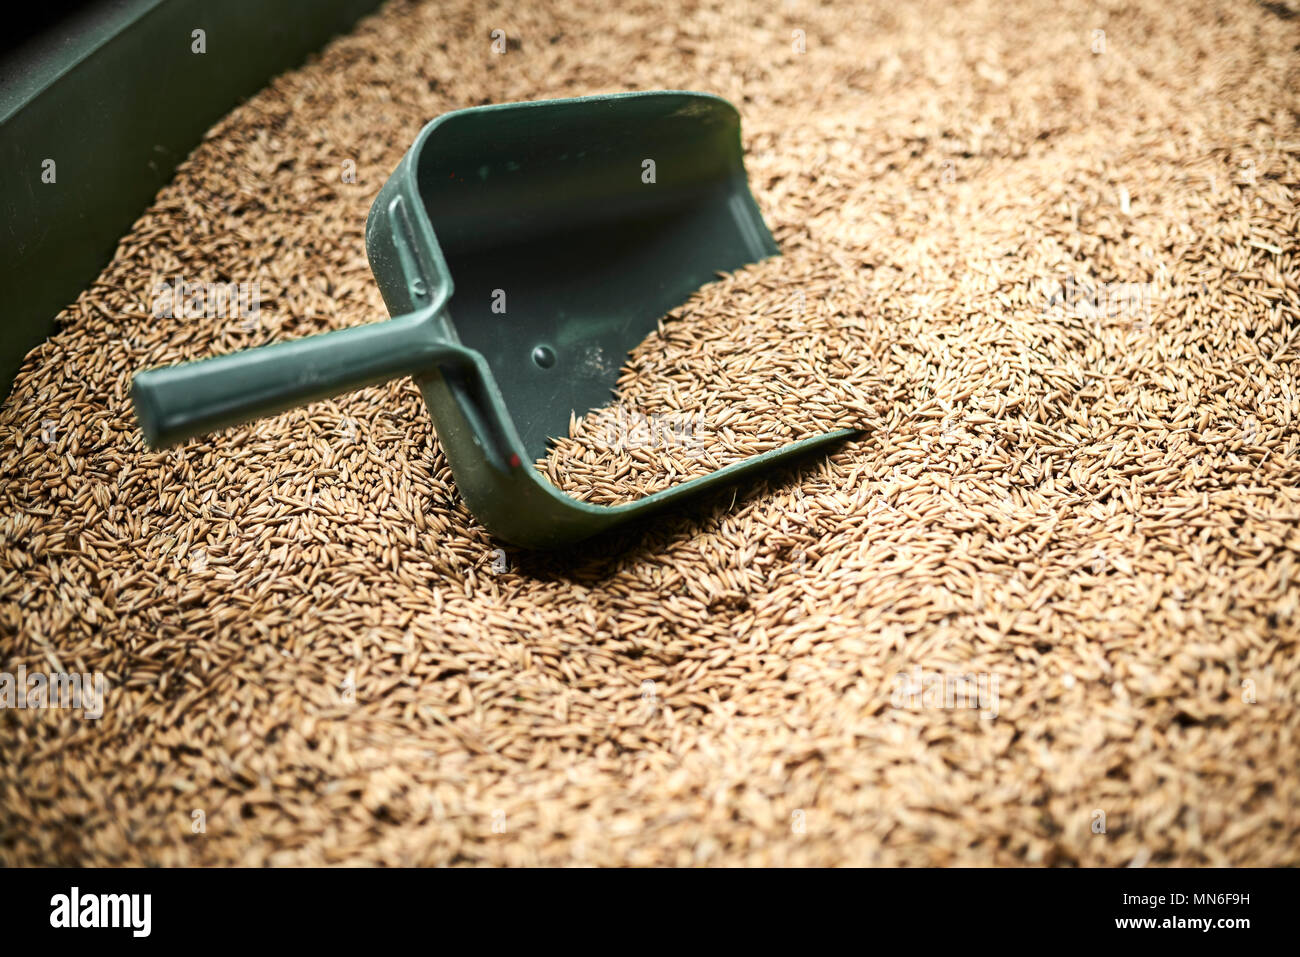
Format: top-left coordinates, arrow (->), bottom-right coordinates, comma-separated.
0,0 -> 1300,865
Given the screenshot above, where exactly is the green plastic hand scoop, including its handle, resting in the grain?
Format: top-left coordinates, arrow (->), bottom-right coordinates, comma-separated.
131,91 -> 855,547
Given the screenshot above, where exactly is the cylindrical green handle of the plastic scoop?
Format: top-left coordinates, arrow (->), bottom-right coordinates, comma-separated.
131,313 -> 473,449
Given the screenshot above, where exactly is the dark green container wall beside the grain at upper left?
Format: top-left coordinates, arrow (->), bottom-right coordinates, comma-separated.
0,0 -> 380,397
